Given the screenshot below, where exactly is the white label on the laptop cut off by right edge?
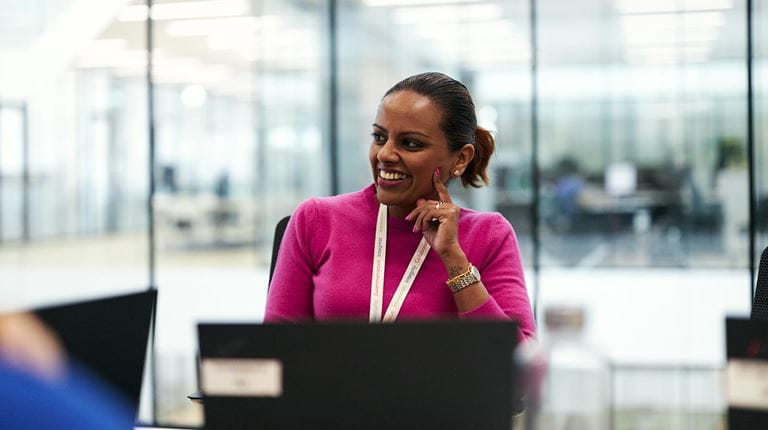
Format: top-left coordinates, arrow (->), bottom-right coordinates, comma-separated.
727,358 -> 768,409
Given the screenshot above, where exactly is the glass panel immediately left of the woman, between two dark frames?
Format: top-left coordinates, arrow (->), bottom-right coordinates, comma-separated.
150,0 -> 329,425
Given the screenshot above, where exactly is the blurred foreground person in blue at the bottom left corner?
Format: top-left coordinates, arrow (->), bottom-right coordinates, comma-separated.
0,313 -> 134,430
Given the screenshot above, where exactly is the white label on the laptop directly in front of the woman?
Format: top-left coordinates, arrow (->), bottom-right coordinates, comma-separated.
201,358 -> 283,397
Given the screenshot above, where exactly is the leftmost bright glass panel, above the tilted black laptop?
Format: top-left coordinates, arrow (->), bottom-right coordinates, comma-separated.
0,0 -> 148,308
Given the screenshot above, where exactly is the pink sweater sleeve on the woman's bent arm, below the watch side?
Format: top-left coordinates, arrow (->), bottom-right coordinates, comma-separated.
459,214 -> 536,340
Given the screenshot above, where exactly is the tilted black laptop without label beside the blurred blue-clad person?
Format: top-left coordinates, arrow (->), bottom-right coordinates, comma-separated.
35,290 -> 157,412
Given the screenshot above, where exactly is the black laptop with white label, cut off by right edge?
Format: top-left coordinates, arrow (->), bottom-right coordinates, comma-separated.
725,317 -> 768,430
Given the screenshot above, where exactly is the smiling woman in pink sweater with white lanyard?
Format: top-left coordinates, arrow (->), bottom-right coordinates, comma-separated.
265,73 -> 535,338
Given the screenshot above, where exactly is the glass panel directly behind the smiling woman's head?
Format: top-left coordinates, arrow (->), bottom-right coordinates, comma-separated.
337,0 -> 533,281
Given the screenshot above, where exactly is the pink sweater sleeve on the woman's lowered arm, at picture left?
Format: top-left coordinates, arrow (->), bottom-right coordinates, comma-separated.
264,199 -> 317,322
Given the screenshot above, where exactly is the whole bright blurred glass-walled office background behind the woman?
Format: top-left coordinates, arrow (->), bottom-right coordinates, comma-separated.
0,0 -> 768,428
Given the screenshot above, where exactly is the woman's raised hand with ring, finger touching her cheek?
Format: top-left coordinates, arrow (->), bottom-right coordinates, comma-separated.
405,170 -> 463,259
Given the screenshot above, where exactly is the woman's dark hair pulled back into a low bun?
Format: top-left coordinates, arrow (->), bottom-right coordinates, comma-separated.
384,72 -> 495,188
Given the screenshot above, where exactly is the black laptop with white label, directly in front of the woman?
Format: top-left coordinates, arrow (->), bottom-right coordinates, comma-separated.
198,321 -> 517,430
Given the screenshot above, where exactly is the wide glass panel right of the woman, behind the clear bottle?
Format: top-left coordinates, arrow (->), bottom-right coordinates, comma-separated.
537,0 -> 750,428
